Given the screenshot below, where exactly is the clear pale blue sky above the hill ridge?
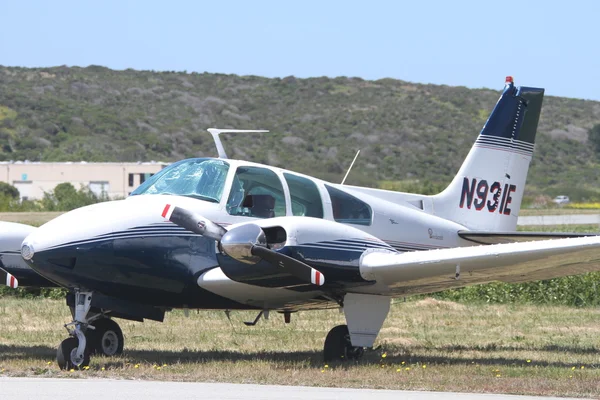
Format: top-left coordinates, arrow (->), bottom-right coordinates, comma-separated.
0,0 -> 600,100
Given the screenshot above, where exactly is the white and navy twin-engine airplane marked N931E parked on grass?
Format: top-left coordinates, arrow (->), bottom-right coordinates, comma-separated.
2,78 -> 600,368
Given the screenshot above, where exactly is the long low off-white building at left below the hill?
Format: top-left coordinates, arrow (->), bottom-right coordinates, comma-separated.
0,161 -> 168,200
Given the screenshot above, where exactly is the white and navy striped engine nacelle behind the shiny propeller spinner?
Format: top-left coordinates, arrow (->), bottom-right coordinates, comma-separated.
217,217 -> 395,290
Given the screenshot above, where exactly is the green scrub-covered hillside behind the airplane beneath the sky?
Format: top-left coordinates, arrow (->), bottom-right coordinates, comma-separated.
0,66 -> 600,197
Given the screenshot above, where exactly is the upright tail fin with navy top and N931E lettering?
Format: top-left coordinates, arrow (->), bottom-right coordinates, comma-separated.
433,77 -> 544,231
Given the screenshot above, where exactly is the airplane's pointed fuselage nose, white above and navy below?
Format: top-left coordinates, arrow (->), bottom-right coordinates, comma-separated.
21,195 -> 223,295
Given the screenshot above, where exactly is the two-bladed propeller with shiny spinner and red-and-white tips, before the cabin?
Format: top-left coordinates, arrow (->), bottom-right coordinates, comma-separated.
162,204 -> 325,286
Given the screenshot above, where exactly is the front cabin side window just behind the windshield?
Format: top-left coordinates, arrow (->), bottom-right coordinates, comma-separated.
227,167 -> 285,218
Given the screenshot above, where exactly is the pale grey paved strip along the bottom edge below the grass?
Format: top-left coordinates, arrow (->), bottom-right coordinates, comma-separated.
0,377 -> 581,400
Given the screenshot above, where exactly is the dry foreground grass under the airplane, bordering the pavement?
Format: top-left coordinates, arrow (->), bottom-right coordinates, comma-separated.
0,298 -> 600,398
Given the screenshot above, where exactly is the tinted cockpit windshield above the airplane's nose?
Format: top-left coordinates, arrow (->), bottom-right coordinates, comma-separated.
131,158 -> 229,203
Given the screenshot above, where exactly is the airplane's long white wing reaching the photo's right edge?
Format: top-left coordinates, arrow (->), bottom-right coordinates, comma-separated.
360,236 -> 600,295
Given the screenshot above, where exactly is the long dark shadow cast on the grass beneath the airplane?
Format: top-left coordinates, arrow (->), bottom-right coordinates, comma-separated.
0,344 -> 599,368
